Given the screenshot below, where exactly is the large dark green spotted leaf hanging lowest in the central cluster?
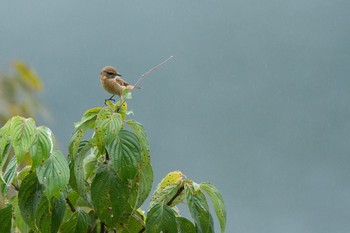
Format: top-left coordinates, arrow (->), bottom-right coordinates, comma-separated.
91,164 -> 129,227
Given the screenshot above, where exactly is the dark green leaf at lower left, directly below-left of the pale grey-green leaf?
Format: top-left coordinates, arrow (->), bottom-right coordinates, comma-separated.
18,172 -> 46,227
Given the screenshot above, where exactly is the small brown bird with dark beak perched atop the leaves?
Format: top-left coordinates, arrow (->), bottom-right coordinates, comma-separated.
100,66 -> 140,101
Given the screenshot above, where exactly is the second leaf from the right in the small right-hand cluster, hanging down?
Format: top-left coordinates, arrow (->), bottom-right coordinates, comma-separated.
185,184 -> 214,233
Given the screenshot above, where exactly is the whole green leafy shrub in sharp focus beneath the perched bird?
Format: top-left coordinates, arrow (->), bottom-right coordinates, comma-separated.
0,102 -> 226,233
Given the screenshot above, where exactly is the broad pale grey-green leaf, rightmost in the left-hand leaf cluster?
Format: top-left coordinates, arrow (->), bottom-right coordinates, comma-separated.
37,150 -> 69,199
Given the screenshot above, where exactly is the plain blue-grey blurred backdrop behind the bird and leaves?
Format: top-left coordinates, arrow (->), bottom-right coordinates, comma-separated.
0,0 -> 350,233
